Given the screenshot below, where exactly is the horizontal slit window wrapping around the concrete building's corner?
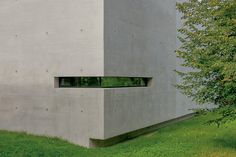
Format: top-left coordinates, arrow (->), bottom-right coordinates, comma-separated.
56,77 -> 151,88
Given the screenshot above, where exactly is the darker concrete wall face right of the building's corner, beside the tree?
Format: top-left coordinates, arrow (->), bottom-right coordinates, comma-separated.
104,0 -> 193,138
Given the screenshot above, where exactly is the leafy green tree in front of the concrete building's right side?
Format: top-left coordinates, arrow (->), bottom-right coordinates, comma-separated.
176,0 -> 236,125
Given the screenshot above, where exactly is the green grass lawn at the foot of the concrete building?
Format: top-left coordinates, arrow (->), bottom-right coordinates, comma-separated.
0,115 -> 236,157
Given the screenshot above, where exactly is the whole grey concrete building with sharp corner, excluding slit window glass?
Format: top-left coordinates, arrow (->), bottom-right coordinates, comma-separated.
0,0 -> 193,147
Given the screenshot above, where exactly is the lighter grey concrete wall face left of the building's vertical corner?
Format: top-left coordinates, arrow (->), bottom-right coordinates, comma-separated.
0,0 -> 104,146
